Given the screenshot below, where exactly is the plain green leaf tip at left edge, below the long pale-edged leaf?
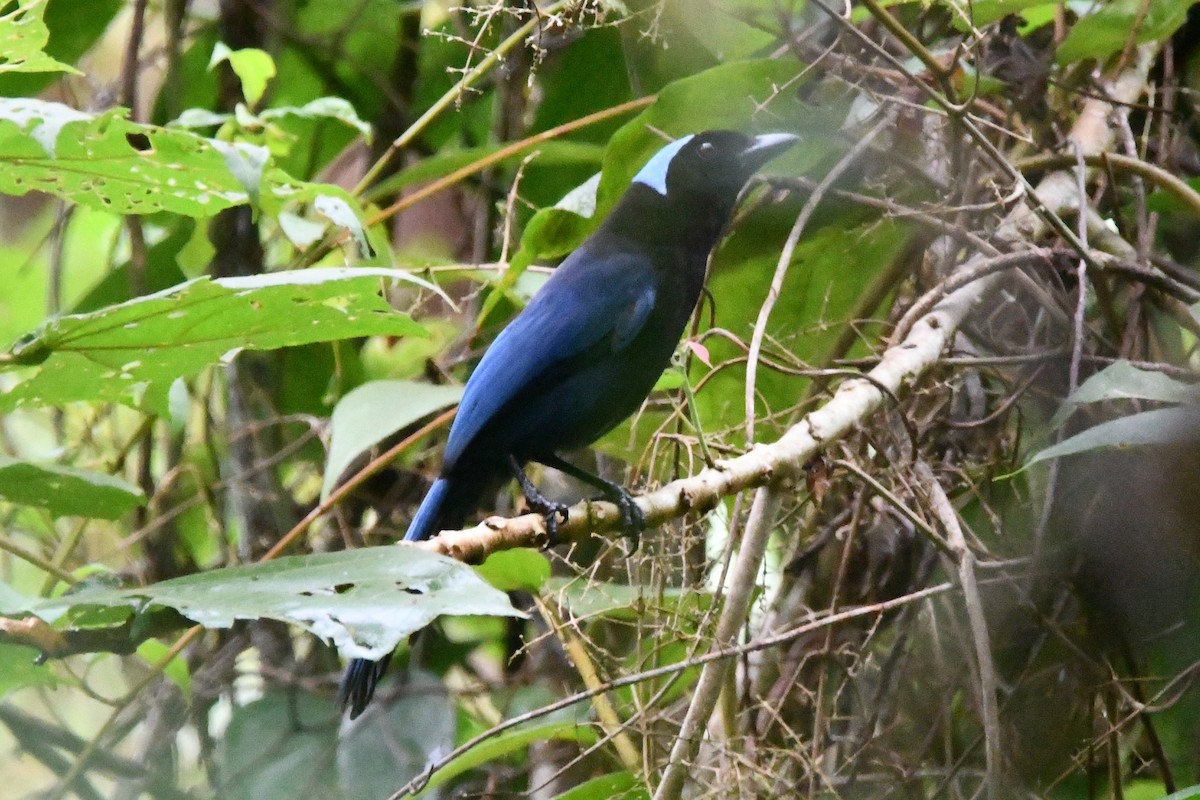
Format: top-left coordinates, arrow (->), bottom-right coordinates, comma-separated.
0,455 -> 145,519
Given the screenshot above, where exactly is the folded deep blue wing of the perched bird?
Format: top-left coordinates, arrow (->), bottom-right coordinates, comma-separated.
443,246 -> 655,474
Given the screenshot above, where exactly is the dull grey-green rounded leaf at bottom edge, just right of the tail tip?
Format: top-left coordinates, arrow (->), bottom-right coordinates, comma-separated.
337,668 -> 457,800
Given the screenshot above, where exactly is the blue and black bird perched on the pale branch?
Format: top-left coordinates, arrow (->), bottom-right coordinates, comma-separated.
338,130 -> 799,720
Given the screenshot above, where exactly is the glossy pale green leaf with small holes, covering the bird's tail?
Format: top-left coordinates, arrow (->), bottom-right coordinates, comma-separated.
35,546 -> 524,658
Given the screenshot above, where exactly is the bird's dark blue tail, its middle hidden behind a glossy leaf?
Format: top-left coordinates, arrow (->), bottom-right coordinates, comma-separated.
337,474 -> 503,720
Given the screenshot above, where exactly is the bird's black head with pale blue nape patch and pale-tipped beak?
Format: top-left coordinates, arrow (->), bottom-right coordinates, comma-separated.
634,131 -> 798,210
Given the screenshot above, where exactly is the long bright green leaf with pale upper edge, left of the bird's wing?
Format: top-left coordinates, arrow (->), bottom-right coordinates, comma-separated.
0,267 -> 437,414
